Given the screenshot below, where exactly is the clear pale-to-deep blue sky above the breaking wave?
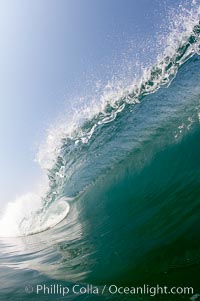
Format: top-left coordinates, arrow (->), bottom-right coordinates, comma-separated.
0,0 -> 180,205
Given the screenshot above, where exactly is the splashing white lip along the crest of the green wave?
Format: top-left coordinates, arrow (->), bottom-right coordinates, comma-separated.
37,3 -> 200,171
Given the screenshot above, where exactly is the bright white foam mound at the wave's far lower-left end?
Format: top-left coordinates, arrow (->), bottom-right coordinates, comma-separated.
0,193 -> 70,237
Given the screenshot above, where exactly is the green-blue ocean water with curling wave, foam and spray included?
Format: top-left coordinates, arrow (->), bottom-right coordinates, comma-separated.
0,2 -> 200,301
